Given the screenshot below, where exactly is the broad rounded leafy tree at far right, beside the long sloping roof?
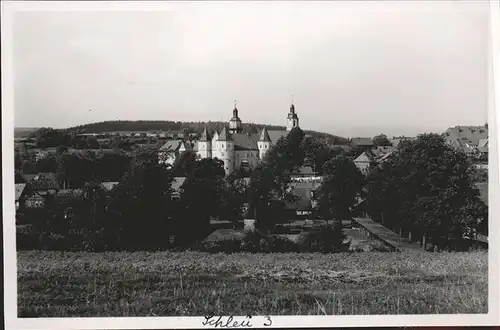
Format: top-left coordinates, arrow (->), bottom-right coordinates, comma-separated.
367,134 -> 487,248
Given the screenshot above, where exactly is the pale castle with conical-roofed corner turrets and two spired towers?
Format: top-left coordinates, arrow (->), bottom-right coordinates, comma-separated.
193,104 -> 299,175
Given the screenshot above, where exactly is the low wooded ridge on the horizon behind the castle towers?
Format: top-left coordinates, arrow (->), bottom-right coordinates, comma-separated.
65,120 -> 346,144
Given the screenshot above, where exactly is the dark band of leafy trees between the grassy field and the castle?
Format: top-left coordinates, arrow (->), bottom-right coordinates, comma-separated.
19,128 -> 488,252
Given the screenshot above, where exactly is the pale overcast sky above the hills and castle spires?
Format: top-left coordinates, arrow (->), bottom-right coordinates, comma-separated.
12,1 -> 489,136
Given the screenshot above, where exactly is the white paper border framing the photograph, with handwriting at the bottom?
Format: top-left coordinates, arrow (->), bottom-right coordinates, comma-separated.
1,0 -> 500,330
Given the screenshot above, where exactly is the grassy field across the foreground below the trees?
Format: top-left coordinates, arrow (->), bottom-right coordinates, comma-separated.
18,251 -> 488,317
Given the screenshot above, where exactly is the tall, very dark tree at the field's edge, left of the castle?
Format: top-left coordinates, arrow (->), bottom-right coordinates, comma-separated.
108,152 -> 175,250
